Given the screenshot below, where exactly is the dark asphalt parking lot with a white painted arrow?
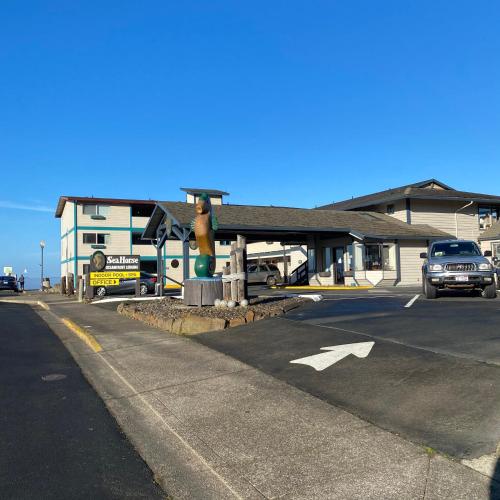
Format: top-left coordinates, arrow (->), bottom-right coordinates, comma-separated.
195,289 -> 500,458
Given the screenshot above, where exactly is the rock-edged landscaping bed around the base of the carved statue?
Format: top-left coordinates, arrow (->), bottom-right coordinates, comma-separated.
117,297 -> 305,335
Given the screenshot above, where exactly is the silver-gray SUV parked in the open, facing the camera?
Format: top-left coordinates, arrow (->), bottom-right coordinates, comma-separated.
420,240 -> 497,299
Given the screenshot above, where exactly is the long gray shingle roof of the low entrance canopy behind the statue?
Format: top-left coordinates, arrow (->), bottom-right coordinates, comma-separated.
144,201 -> 450,239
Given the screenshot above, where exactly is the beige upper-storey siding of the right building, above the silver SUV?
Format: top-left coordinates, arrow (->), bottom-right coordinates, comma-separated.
411,200 -> 479,240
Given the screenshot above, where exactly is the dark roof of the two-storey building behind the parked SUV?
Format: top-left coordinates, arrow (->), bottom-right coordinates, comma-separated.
319,183 -> 500,210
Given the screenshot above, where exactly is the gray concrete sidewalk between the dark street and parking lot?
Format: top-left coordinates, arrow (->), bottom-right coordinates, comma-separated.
4,295 -> 498,500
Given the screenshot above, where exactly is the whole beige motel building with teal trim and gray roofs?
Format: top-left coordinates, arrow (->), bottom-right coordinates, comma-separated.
56,179 -> 500,286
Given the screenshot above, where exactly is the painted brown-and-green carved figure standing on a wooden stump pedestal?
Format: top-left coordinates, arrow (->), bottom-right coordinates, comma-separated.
191,193 -> 218,278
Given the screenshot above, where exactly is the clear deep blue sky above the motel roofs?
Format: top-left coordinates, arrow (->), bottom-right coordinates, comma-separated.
0,0 -> 500,276
